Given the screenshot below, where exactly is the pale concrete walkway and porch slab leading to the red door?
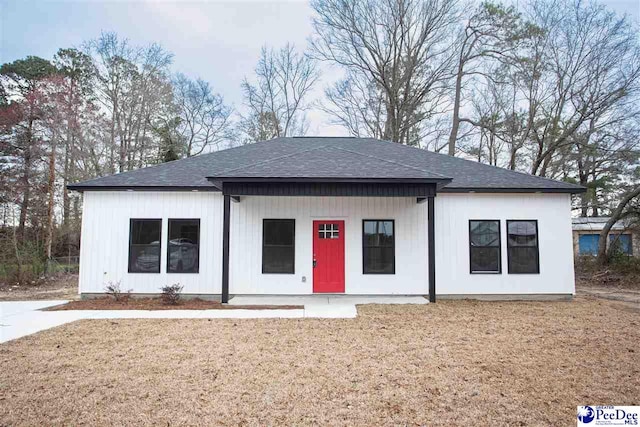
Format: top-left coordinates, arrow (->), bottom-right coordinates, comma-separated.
0,296 -> 428,343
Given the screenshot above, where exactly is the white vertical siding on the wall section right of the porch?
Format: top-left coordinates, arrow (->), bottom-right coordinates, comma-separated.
435,193 -> 575,295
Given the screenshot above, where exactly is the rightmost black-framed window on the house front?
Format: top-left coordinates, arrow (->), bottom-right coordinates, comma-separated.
507,220 -> 540,274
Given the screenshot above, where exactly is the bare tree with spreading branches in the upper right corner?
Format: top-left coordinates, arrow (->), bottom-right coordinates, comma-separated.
519,0 -> 640,176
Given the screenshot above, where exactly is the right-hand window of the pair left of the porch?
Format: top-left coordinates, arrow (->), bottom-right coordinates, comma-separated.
167,219 -> 200,273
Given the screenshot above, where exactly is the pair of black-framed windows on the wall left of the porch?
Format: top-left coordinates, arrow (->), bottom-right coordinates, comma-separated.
129,219 -> 200,273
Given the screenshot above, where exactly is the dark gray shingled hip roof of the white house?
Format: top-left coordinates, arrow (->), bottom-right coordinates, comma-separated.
69,137 -> 584,193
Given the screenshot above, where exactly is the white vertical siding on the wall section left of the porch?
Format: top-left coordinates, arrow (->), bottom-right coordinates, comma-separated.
79,191 -> 222,294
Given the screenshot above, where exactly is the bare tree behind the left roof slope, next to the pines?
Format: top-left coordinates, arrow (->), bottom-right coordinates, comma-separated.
173,74 -> 231,157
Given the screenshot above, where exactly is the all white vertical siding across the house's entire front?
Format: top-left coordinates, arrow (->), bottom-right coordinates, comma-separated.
80,191 -> 574,295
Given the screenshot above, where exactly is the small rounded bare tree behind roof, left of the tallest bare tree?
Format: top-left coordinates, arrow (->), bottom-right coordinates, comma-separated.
240,44 -> 319,142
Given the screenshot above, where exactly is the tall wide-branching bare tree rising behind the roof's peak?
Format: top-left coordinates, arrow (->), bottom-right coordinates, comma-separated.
311,0 -> 459,143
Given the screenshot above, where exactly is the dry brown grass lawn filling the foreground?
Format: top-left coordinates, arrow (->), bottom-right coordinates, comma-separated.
0,298 -> 640,425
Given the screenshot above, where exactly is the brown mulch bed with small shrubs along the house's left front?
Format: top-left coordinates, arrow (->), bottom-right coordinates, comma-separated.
43,297 -> 304,311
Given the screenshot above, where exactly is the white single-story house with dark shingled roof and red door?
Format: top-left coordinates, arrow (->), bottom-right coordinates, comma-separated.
69,137 -> 583,302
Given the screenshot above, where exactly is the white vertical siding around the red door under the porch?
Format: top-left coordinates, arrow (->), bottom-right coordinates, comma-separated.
229,197 -> 428,295
